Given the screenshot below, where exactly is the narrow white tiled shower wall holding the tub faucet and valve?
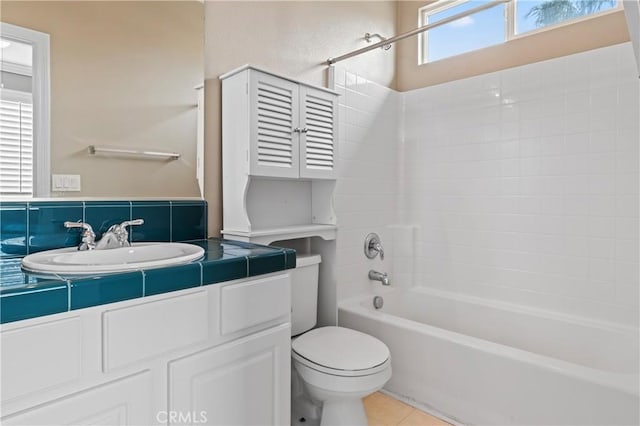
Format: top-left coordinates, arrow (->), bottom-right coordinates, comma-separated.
334,68 -> 400,300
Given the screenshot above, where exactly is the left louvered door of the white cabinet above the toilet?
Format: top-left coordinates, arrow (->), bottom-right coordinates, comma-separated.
249,71 -> 300,178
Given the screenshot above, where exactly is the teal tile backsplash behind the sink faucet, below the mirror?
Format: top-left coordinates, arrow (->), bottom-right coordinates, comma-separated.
0,200 -> 207,258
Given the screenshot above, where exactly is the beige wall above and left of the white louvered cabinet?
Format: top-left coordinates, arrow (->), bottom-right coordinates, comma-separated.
205,1 -> 396,235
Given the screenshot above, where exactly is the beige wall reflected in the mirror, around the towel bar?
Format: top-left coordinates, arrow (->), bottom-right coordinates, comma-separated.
1,0 -> 204,197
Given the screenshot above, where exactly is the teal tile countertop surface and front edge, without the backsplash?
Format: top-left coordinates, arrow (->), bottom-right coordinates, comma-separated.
0,238 -> 296,323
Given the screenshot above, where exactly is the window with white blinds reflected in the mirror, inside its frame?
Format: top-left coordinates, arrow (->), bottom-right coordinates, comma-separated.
0,37 -> 33,196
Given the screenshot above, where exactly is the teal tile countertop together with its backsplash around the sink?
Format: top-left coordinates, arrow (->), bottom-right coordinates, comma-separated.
0,200 -> 295,323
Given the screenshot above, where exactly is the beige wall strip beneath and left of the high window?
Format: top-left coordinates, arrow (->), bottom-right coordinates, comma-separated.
396,1 -> 629,91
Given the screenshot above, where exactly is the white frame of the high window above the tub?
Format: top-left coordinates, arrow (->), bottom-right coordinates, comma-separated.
418,0 -> 623,65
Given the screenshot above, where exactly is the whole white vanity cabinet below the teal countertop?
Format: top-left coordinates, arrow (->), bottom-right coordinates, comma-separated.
0,272 -> 291,425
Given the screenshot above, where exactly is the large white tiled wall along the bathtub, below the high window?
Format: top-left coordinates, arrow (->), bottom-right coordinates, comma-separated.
408,43 -> 640,324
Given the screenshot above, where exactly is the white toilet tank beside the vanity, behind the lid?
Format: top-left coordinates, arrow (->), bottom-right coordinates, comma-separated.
291,254 -> 321,336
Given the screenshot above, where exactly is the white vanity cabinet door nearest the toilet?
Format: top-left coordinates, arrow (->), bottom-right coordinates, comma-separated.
169,323 -> 291,425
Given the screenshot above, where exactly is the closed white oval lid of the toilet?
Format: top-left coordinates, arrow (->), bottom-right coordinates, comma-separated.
291,327 -> 389,370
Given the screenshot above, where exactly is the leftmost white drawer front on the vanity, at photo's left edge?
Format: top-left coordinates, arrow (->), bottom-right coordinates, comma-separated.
0,317 -> 82,401
